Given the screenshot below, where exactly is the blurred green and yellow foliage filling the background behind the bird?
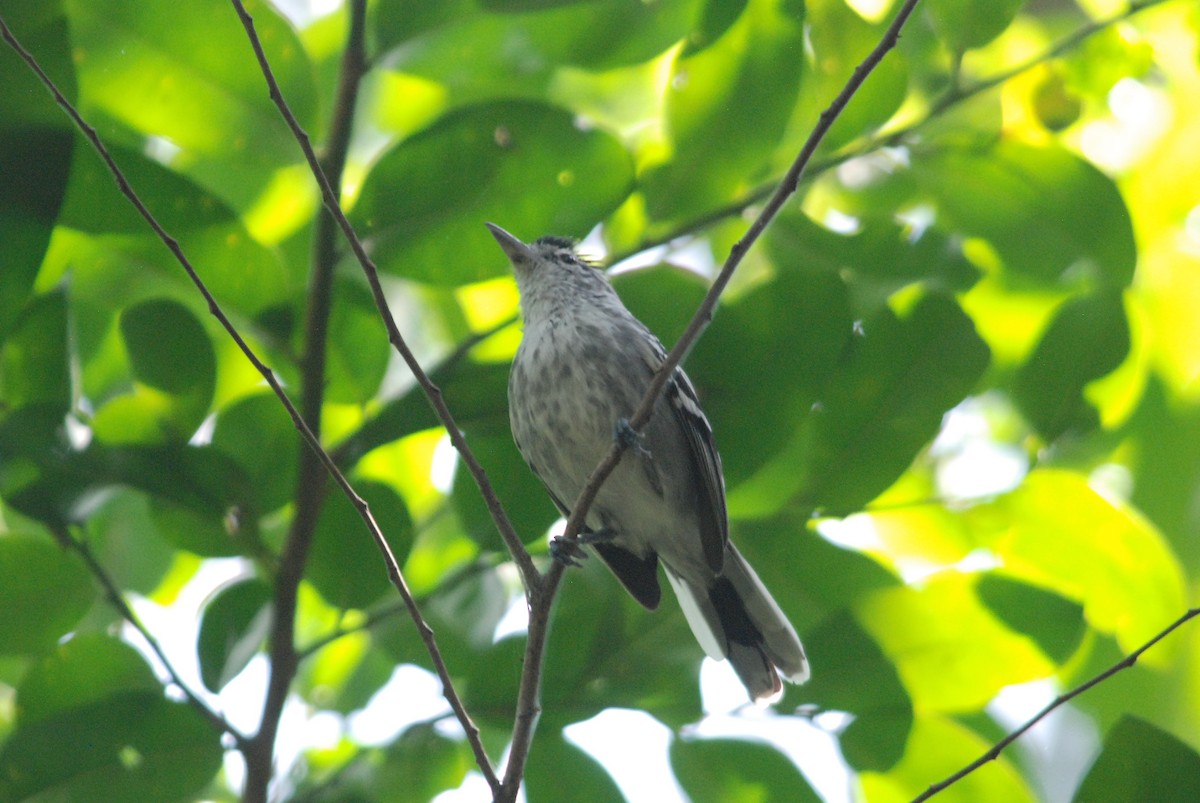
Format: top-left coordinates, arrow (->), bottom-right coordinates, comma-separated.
0,0 -> 1200,803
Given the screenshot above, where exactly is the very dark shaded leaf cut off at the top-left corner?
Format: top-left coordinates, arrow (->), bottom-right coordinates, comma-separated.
0,0 -> 76,342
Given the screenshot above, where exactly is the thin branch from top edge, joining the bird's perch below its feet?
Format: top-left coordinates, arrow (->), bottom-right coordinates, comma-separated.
232,0 -> 541,589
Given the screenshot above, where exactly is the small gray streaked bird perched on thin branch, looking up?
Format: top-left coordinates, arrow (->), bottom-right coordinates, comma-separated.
487,223 -> 809,701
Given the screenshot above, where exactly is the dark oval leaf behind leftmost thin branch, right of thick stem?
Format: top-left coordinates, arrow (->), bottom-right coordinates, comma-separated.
305,483 -> 413,609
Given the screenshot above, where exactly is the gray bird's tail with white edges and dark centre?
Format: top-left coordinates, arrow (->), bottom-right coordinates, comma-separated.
667,544 -> 809,702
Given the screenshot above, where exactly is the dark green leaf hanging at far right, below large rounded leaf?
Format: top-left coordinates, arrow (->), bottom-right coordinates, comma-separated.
1013,290 -> 1129,441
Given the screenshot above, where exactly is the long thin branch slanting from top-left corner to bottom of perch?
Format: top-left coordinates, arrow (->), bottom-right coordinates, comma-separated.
0,6 -> 494,796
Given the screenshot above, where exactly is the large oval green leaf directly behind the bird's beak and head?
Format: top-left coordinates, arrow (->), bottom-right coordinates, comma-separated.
353,102 -> 632,284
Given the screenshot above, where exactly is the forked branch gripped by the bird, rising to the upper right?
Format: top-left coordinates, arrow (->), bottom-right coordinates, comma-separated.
499,0 -> 919,802
